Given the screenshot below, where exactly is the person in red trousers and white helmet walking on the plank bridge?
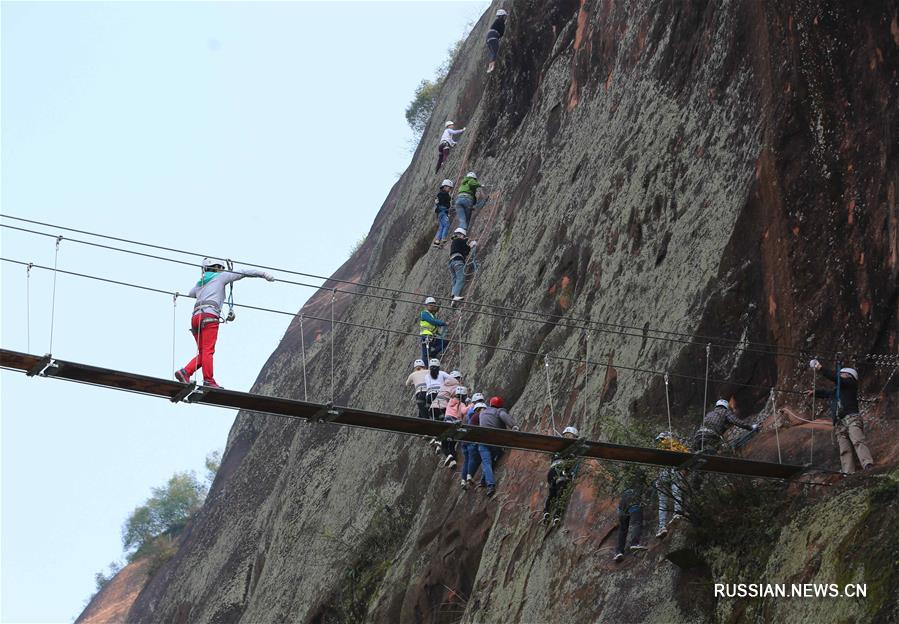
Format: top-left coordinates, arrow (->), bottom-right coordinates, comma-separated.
175,258 -> 275,388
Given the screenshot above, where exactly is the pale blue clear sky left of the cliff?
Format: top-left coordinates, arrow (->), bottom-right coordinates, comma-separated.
0,1 -> 488,622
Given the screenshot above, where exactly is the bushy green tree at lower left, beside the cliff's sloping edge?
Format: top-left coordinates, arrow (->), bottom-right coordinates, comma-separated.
122,466 -> 208,561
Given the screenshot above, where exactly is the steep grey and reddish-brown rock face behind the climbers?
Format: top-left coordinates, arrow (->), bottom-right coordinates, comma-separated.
121,0 -> 899,623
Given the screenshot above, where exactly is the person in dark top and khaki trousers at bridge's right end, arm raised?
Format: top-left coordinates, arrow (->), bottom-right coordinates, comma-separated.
807,360 -> 874,474
